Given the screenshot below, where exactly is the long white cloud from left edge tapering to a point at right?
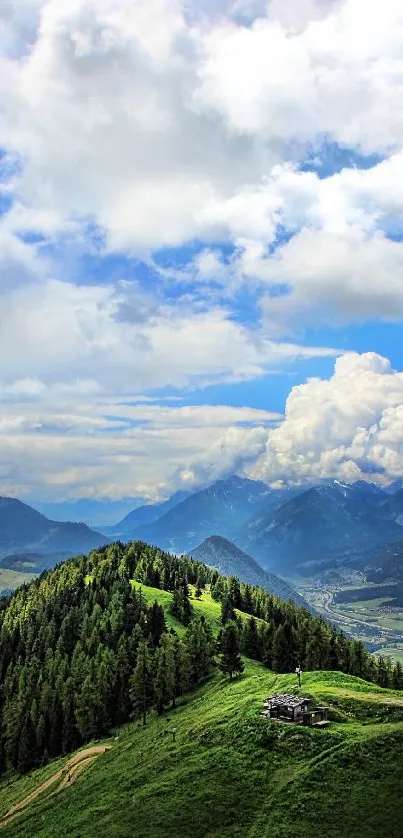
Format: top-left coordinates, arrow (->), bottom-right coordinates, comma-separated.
0,281 -> 334,393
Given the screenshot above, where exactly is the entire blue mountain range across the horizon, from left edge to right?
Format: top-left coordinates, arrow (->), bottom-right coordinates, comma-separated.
0,475 -> 403,579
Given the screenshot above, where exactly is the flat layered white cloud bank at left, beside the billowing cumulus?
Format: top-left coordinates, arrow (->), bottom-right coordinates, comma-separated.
0,399 -> 279,499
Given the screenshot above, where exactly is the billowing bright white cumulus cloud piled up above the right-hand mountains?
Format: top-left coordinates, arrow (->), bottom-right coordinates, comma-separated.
252,353 -> 403,483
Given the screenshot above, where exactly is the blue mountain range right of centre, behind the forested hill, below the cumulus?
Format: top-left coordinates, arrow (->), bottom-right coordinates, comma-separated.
110,476 -> 403,578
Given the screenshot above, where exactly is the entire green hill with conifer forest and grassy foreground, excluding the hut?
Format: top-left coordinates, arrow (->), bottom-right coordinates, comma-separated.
0,542 -> 403,838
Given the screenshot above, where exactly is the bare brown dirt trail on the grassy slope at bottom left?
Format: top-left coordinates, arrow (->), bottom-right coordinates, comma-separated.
0,745 -> 112,828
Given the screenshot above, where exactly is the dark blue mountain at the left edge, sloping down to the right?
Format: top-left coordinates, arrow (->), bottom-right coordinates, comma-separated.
0,497 -> 106,566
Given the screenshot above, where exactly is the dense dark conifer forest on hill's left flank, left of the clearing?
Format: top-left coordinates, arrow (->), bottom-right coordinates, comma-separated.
0,545 -> 216,773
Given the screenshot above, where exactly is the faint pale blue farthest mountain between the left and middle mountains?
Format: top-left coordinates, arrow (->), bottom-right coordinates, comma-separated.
31,498 -> 143,528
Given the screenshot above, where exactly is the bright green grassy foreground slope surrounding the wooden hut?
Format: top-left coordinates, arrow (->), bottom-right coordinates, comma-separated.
0,587 -> 403,838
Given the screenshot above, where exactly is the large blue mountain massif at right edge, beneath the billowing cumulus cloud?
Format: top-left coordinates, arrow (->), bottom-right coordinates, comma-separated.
235,481 -> 403,577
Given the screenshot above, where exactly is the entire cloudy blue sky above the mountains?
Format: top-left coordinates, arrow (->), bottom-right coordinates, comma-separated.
0,0 -> 403,501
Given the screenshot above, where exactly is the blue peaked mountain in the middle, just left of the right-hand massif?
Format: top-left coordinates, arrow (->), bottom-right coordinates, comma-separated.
135,475 -> 271,553
